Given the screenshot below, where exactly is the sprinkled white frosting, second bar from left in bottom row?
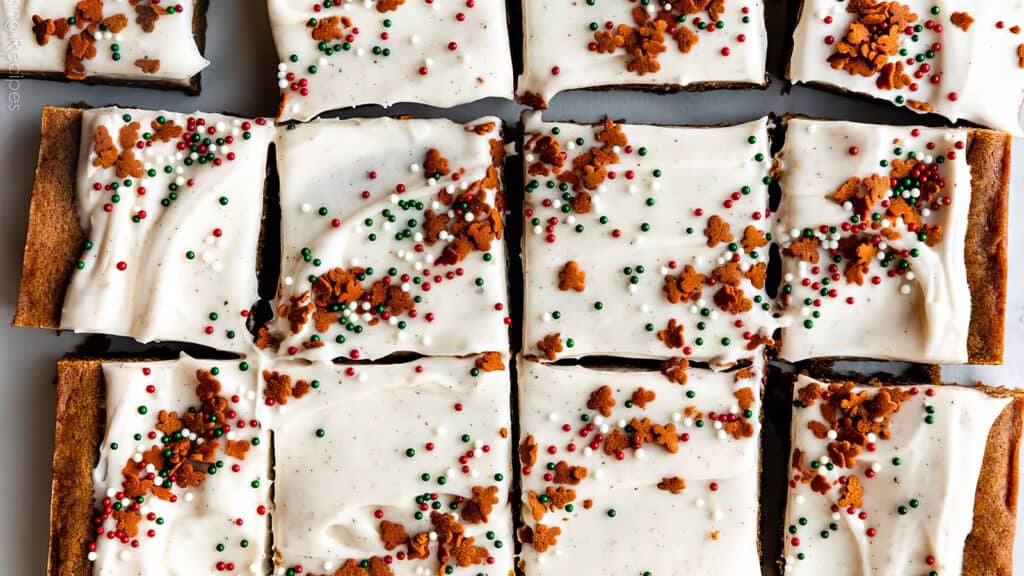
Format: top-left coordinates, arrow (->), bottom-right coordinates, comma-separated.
262,354 -> 514,576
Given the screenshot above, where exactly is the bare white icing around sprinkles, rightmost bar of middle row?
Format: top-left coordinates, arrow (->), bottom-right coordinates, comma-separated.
776,119 -> 971,363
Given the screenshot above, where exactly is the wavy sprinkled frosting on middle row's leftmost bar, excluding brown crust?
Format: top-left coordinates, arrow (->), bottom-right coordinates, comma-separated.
60,108 -> 273,352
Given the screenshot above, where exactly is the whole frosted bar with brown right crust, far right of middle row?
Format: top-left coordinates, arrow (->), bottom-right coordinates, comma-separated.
775,119 -> 1011,364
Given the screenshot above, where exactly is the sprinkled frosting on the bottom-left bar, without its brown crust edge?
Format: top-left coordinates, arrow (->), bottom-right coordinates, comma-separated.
89,355 -> 270,576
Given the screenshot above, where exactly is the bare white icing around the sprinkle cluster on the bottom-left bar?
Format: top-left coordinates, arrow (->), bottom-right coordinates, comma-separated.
93,355 -> 270,576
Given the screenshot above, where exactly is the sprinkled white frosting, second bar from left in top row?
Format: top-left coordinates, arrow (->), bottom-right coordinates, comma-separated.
269,0 -> 512,120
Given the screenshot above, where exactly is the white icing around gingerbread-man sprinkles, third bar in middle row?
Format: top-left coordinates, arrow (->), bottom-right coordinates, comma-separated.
523,114 -> 774,364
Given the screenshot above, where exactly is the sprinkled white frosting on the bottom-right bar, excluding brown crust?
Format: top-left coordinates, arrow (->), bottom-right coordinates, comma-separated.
785,376 -> 1011,576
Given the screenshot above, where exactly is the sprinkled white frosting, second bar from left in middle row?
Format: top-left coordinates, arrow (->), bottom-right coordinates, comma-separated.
270,118 -> 509,360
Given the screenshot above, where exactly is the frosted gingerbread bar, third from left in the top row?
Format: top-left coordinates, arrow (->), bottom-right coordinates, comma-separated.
518,0 -> 768,109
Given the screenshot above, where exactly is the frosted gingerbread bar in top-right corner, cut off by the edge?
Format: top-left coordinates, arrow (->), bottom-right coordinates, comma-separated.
787,0 -> 1024,135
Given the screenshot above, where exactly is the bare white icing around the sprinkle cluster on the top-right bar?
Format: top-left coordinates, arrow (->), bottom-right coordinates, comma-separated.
790,0 -> 1024,135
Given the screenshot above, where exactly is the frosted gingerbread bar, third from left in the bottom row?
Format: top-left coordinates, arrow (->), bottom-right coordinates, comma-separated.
519,360 -> 762,576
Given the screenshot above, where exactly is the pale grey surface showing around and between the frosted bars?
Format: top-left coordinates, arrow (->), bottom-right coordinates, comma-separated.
0,0 -> 1024,575
